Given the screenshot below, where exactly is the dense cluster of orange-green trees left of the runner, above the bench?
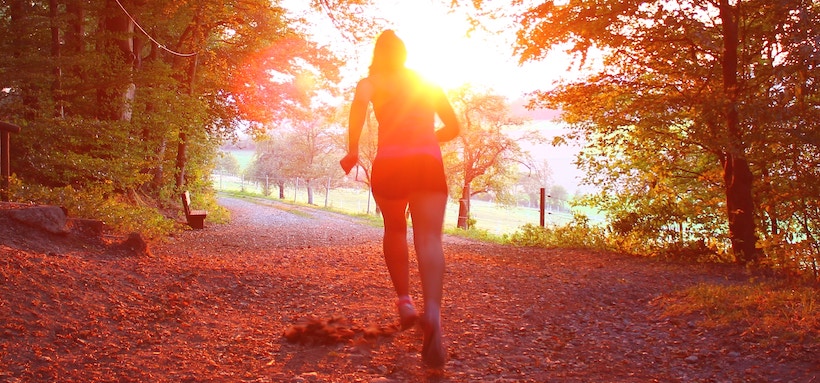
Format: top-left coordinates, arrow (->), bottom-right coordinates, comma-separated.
0,0 -> 340,202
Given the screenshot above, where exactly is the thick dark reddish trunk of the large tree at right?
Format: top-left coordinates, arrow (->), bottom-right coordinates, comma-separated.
720,0 -> 759,264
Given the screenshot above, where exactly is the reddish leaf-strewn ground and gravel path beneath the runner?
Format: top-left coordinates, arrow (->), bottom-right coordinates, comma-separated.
0,196 -> 820,383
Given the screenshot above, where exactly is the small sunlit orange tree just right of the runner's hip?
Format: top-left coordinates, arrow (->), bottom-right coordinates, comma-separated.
444,86 -> 537,229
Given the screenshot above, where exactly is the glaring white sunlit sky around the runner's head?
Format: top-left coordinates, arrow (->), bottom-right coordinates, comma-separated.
286,0 -> 580,100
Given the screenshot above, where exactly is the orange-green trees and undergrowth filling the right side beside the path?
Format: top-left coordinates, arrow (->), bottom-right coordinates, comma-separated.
494,0 -> 820,279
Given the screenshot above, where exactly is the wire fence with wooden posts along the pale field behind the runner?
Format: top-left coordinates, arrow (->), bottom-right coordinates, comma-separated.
211,173 -> 573,235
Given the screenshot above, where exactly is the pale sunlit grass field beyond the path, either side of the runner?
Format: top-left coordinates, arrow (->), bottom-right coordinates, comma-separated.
213,175 -> 572,235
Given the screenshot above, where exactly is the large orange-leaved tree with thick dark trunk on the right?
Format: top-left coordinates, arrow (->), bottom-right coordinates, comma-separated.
468,0 -> 820,264
